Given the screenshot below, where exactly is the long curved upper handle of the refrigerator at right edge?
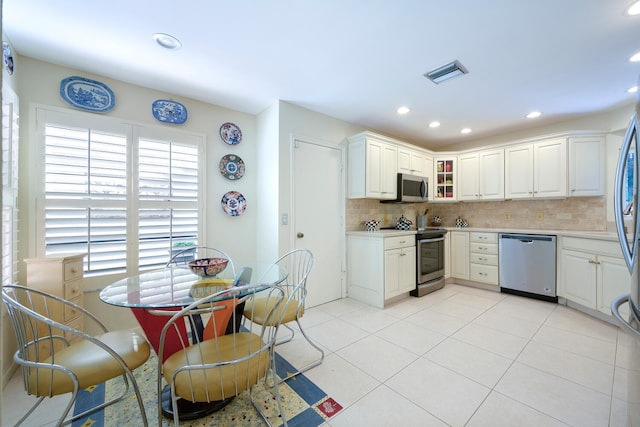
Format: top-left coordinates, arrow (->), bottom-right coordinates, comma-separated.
613,114 -> 640,271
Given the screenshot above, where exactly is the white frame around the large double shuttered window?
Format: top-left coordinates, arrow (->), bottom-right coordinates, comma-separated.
31,106 -> 207,277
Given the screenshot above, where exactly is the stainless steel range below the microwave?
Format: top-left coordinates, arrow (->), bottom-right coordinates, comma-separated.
411,227 -> 447,297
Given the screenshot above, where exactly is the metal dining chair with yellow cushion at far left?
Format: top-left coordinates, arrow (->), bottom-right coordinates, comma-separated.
2,285 -> 150,426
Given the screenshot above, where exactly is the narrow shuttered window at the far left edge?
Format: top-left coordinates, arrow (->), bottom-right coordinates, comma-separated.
1,87 -> 19,284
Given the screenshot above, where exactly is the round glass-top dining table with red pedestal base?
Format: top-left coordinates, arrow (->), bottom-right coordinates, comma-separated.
100,262 -> 288,419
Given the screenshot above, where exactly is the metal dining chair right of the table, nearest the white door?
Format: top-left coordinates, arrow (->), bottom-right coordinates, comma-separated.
244,248 -> 324,382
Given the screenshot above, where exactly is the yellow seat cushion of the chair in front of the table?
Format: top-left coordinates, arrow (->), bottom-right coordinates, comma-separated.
162,332 -> 269,402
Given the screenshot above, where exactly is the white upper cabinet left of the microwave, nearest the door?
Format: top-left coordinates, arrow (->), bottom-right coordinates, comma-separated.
348,132 -> 398,200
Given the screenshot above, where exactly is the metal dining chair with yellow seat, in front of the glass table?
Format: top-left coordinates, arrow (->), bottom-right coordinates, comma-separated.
158,285 -> 287,426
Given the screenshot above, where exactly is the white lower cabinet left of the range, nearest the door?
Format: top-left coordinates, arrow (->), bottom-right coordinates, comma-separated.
347,232 -> 416,308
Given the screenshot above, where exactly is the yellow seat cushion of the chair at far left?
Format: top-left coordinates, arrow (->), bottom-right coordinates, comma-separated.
28,331 -> 150,396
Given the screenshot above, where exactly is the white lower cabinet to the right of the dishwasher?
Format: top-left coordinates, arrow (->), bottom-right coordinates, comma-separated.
558,237 -> 631,315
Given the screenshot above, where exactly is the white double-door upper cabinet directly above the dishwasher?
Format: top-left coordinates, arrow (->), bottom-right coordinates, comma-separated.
505,138 -> 567,199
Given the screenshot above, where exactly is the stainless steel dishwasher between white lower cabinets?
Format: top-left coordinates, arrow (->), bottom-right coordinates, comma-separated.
498,233 -> 558,302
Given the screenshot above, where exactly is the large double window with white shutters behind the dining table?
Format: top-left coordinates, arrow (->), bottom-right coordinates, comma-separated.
39,110 -> 203,275
